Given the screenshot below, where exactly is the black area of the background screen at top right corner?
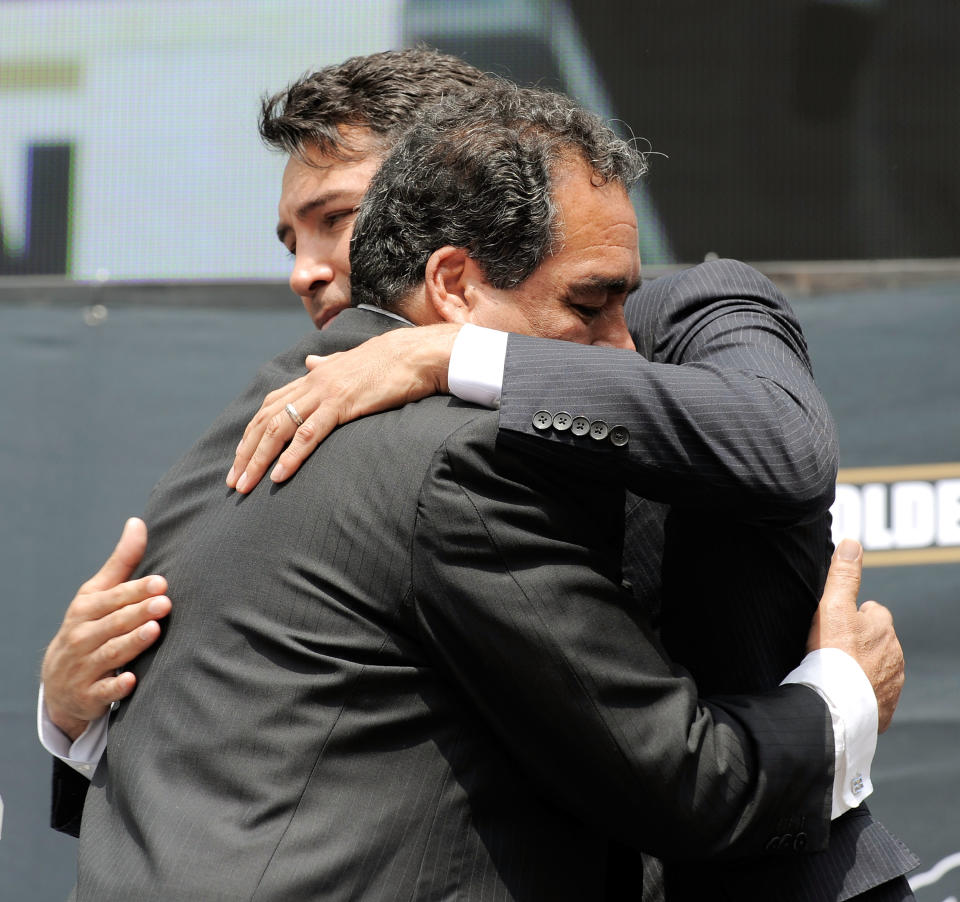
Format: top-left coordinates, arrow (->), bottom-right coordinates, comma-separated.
571,0 -> 960,260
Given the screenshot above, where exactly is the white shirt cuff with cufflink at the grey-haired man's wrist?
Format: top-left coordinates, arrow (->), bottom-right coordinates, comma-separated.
781,648 -> 879,819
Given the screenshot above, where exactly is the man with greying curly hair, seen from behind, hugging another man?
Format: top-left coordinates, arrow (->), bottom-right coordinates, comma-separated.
77,81 -> 901,902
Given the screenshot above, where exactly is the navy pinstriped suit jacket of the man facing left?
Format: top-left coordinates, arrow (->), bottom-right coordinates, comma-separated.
501,260 -> 917,902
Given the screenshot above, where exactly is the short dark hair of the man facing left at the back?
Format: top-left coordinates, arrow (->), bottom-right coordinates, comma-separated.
260,47 -> 485,162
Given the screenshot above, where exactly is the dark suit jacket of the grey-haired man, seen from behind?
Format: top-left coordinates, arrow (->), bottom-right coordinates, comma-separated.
71,310 -> 833,902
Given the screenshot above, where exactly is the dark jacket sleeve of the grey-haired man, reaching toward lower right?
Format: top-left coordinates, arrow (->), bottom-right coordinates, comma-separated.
411,419 -> 833,857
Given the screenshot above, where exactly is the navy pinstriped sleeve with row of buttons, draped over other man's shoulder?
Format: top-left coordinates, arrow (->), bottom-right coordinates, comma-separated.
500,260 -> 838,522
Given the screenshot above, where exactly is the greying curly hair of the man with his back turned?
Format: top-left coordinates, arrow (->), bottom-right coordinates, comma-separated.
350,82 -> 647,309
